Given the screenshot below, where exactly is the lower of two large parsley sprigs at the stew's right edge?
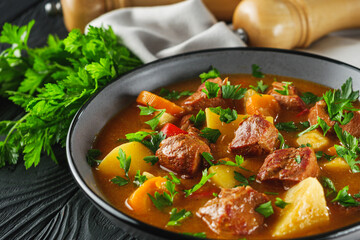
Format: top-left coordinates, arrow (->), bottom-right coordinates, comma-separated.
334,123 -> 360,173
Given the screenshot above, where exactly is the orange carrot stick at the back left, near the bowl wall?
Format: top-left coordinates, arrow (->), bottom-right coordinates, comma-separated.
136,91 -> 184,116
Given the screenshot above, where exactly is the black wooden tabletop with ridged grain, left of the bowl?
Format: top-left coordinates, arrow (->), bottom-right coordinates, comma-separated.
0,0 -> 134,240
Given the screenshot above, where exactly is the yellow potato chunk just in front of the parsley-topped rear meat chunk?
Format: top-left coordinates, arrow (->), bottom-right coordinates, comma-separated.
205,108 -> 274,138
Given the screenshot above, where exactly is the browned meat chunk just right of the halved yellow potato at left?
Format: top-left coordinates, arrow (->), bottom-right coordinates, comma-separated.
156,134 -> 210,177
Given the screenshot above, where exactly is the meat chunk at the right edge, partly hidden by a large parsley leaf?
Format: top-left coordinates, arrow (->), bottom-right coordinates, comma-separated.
308,100 -> 360,138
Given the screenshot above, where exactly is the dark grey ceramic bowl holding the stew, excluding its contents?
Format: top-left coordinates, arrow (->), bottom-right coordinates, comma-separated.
66,48 -> 360,239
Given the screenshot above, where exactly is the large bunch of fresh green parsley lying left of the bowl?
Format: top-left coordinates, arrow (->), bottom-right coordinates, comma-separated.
0,21 -> 142,168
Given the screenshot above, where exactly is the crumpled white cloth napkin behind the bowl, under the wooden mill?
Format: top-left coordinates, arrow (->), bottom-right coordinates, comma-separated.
89,0 -> 360,67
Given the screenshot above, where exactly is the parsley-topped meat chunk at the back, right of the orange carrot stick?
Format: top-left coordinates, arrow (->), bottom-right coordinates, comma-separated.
181,78 -> 231,112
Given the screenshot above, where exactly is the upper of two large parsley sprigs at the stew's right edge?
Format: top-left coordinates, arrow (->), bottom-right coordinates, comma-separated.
323,78 -> 359,125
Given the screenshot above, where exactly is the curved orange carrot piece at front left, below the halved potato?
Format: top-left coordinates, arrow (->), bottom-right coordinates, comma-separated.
127,177 -> 167,215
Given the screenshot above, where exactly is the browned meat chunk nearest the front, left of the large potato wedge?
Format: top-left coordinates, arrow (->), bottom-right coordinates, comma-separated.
197,186 -> 269,238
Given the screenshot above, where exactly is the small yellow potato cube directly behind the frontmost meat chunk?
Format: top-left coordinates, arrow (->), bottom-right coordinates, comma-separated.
209,165 -> 239,188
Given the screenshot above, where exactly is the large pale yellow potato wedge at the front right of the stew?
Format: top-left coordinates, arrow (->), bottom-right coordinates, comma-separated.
273,178 -> 329,237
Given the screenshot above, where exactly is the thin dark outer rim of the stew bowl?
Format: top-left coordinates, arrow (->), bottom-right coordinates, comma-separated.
66,47 -> 360,240
